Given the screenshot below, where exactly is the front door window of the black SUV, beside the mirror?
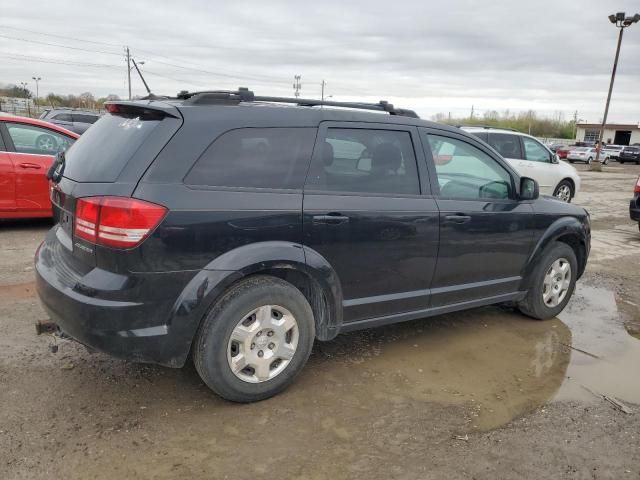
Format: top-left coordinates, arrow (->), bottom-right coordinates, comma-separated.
426,135 -> 512,200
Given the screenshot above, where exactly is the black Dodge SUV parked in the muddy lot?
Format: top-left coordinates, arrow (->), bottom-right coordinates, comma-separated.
35,89 -> 590,402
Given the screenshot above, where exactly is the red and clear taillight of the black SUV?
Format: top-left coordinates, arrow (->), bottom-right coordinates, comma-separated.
74,197 -> 167,248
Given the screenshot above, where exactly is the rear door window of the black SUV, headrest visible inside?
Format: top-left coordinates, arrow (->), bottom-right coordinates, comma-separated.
307,128 -> 420,195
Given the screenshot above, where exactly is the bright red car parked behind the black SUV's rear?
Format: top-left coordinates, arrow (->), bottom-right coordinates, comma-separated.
0,113 -> 80,219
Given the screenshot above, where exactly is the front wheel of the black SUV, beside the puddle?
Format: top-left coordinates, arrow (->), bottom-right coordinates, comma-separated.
518,242 -> 578,320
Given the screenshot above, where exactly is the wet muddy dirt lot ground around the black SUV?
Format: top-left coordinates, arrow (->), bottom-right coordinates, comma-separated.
0,163 -> 640,480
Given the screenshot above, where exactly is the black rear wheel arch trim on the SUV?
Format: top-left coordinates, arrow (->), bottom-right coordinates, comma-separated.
169,241 -> 342,359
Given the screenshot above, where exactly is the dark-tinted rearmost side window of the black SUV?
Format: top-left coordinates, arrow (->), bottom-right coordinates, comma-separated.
184,128 -> 316,189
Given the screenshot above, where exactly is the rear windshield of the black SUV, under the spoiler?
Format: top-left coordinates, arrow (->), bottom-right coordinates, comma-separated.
64,114 -> 160,182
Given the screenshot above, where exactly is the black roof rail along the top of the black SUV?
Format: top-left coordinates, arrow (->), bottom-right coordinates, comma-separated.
177,87 -> 420,118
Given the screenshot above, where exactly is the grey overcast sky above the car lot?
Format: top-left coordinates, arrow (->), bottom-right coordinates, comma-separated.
0,0 -> 640,123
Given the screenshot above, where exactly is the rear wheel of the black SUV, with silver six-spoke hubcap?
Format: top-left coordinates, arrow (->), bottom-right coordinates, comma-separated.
193,275 -> 315,403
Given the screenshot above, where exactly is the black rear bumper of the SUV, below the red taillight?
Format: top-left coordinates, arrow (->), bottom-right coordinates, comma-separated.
35,227 -> 199,367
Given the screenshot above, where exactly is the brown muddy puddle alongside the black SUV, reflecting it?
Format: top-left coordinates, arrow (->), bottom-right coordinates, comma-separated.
282,285 -> 640,431
